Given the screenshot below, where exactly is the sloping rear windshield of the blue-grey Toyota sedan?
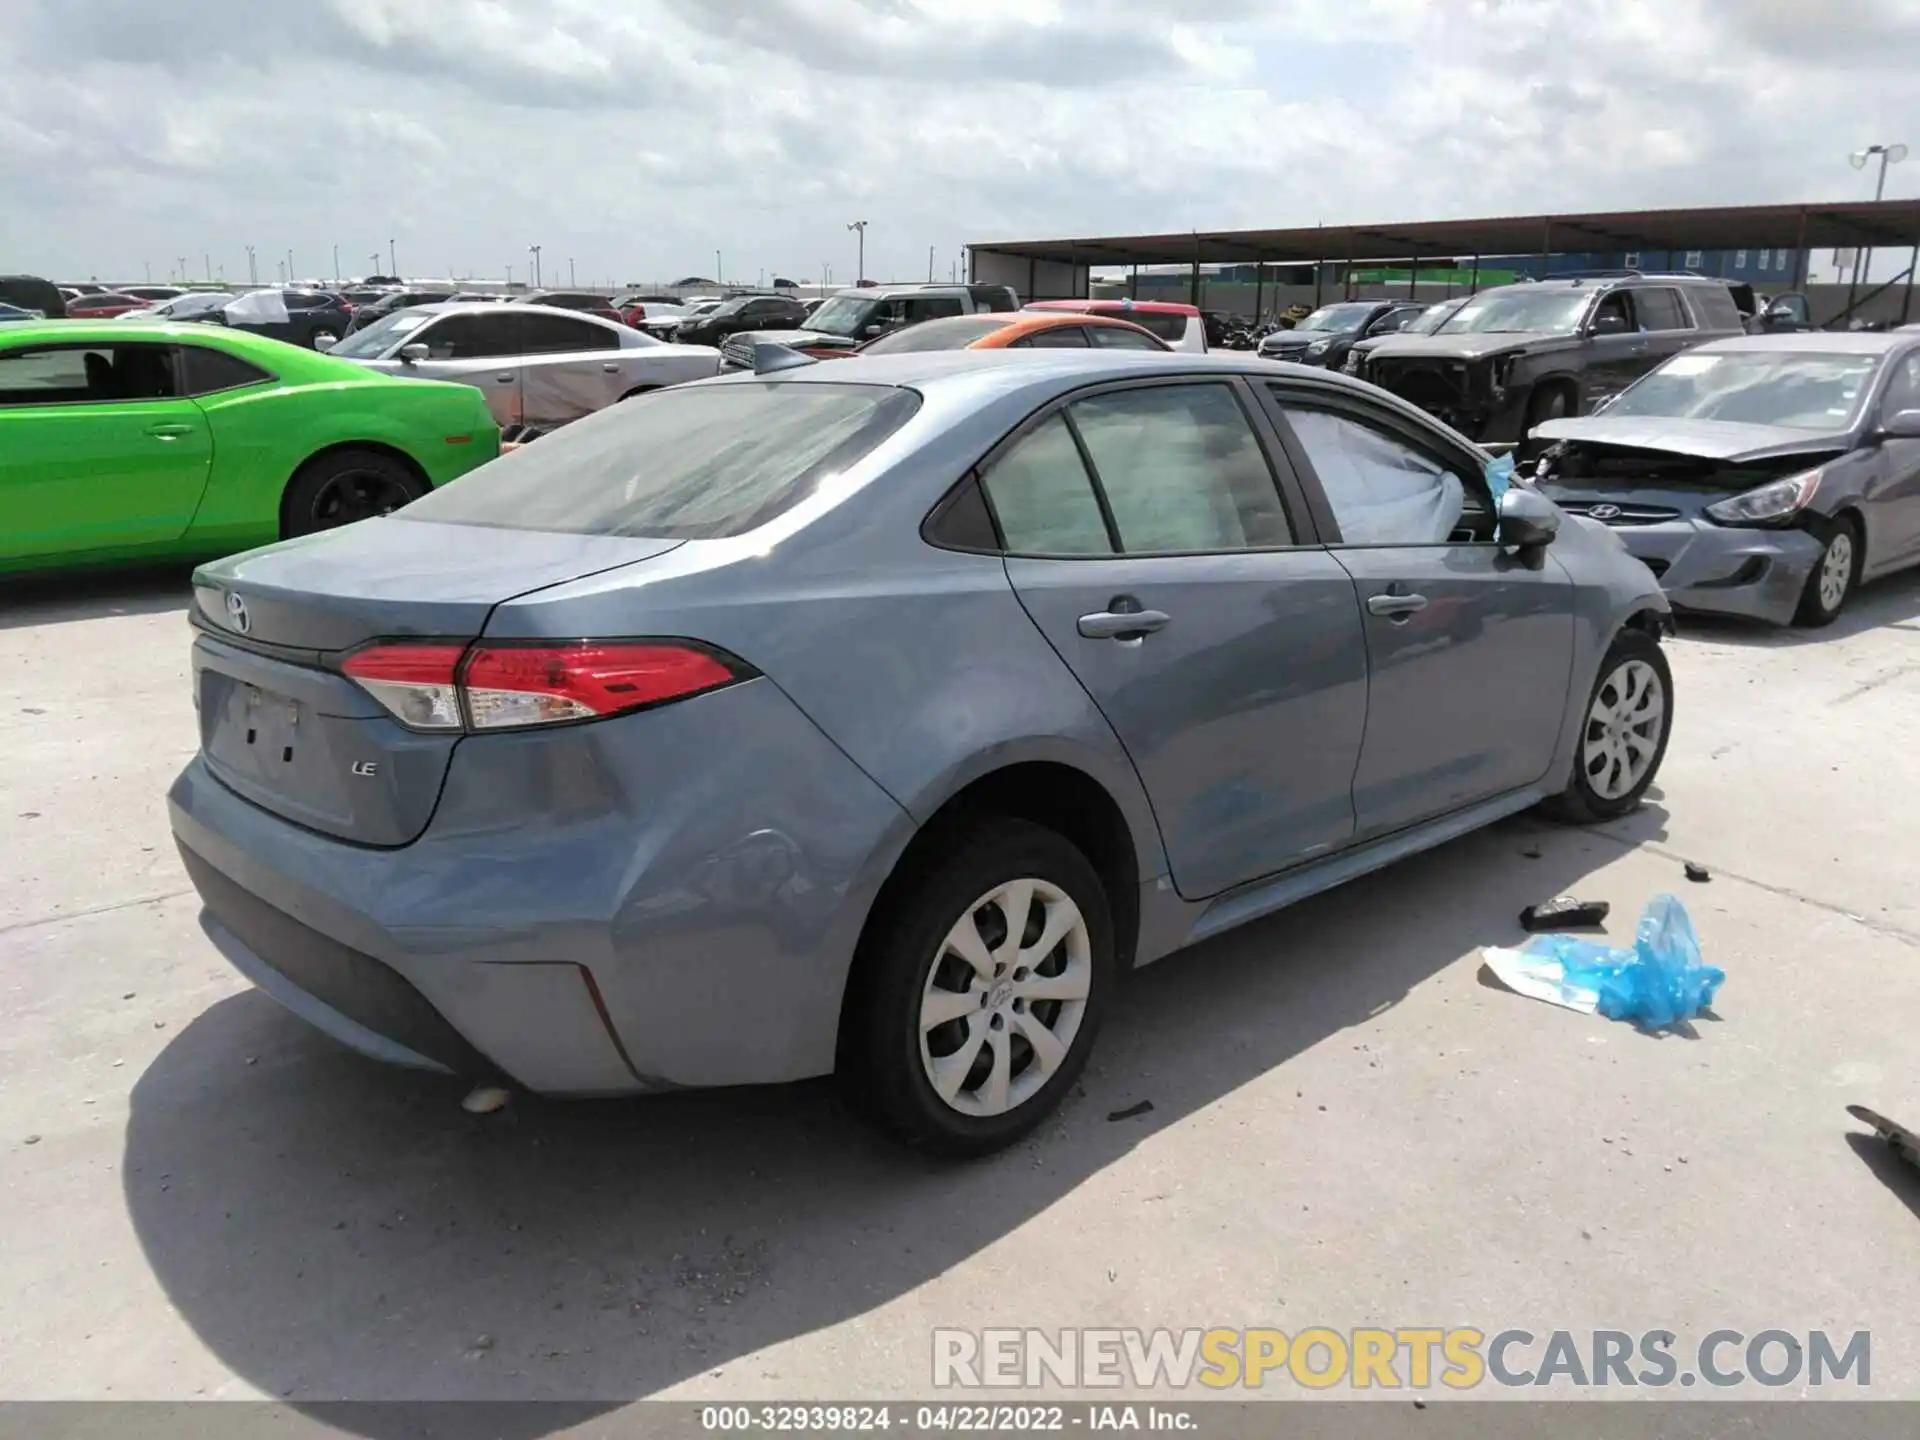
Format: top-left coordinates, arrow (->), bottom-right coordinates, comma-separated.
401,380 -> 920,540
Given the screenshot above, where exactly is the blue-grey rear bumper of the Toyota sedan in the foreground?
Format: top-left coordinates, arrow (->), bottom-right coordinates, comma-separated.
169,682 -> 912,1094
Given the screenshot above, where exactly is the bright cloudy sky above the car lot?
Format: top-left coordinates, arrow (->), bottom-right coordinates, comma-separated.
0,0 -> 1920,284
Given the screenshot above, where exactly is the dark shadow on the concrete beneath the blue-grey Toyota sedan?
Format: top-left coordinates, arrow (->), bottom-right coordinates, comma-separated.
123,808 -> 1663,1436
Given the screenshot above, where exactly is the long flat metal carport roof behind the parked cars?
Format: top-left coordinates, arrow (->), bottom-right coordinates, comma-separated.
968,200 -> 1920,265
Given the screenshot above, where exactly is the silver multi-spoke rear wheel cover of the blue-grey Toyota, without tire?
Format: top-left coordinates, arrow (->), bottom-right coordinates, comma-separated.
920,877 -> 1092,1117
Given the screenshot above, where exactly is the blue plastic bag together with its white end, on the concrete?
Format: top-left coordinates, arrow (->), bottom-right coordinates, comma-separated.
1480,895 -> 1726,1029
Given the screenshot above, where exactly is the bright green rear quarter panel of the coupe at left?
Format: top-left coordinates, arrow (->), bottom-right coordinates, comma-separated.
188,378 -> 499,549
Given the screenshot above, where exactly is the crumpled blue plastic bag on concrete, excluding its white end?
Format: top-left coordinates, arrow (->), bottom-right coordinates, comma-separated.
1521,895 -> 1726,1029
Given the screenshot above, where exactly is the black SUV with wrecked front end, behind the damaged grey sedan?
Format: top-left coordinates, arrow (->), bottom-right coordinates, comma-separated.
1357,275 -> 1745,442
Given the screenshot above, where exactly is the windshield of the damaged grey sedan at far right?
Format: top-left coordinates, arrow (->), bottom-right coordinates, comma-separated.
1605,349 -> 1880,432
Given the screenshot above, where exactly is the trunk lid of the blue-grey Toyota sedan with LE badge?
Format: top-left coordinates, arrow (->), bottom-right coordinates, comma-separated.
194,518 -> 680,847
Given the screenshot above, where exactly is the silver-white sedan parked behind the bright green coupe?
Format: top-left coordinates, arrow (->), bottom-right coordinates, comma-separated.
332,301 -> 720,430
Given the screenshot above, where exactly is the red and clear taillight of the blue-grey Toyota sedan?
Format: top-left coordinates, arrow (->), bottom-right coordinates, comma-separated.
342,639 -> 755,732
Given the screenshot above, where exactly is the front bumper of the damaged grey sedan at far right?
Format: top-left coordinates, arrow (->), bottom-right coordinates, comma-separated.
1615,520 -> 1820,624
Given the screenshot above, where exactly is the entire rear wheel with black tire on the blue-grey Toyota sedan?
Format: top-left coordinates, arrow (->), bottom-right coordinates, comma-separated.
839,818 -> 1114,1158
